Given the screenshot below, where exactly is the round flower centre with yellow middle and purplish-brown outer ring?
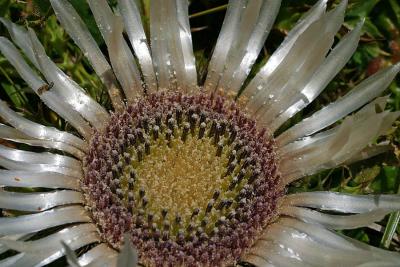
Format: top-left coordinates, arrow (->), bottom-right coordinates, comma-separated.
82,92 -> 282,265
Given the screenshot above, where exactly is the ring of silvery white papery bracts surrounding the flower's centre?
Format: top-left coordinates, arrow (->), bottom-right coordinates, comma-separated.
0,0 -> 400,267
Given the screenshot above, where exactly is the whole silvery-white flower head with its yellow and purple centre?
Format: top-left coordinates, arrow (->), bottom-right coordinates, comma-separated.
0,0 -> 400,266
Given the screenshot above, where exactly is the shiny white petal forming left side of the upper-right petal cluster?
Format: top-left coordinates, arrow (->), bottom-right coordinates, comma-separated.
242,0 -> 327,99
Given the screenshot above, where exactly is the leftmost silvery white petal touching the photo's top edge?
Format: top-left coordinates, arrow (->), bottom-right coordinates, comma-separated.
50,0 -> 123,110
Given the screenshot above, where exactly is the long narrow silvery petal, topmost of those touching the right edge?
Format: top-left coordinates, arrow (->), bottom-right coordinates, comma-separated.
277,63 -> 400,146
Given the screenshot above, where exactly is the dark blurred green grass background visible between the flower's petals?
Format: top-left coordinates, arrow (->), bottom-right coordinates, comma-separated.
0,0 -> 400,262
